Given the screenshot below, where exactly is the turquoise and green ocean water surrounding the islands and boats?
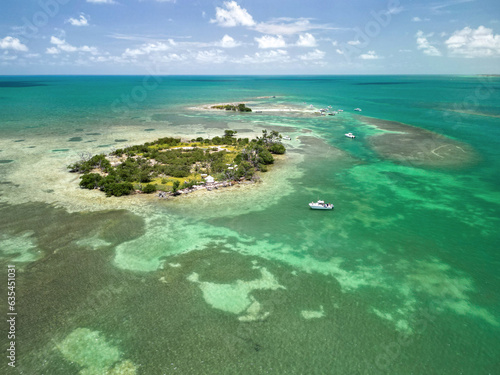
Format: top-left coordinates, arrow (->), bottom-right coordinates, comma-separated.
0,76 -> 500,375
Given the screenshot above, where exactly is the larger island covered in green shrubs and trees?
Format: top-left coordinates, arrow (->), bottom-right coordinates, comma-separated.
68,130 -> 286,198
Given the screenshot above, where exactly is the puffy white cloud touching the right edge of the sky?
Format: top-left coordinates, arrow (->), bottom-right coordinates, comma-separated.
445,26 -> 500,58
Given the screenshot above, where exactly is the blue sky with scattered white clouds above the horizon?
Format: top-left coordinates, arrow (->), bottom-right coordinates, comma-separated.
0,0 -> 500,74
